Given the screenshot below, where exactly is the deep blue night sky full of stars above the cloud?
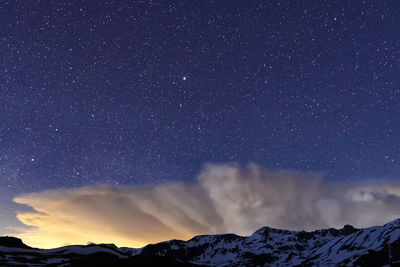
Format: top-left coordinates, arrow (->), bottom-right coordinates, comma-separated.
0,0 -> 400,237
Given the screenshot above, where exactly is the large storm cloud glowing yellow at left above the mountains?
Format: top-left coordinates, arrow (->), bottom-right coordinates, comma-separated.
10,164 -> 400,247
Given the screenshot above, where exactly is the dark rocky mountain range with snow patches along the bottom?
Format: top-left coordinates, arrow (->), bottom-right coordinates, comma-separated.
0,219 -> 400,267
